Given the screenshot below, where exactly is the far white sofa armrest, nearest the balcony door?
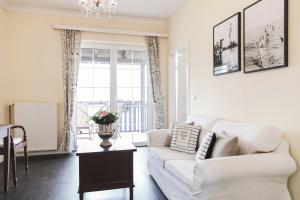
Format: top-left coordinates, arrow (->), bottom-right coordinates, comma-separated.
148,129 -> 170,147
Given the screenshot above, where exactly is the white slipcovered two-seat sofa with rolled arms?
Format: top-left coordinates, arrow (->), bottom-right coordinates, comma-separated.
148,115 -> 296,200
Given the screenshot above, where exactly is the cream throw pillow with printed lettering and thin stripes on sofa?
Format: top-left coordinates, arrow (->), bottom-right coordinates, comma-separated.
170,123 -> 201,154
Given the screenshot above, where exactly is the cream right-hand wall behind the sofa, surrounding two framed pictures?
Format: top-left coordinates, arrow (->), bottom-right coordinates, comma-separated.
170,0 -> 300,199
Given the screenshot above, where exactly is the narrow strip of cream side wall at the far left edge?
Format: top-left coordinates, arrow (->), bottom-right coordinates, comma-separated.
0,6 -> 7,124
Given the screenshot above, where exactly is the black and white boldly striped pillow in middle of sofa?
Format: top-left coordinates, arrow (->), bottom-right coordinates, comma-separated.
196,131 -> 217,160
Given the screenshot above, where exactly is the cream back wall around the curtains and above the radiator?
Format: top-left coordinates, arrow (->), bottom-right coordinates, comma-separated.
6,12 -> 169,141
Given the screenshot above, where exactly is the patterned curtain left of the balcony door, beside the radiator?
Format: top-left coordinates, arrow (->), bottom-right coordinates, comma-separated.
60,30 -> 81,152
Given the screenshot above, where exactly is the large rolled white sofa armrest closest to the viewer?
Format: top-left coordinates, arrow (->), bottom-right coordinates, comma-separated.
193,153 -> 296,188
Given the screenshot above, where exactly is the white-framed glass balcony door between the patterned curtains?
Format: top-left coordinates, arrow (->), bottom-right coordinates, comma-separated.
77,42 -> 152,146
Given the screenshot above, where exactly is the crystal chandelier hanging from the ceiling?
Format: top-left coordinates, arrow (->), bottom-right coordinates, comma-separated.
79,0 -> 118,18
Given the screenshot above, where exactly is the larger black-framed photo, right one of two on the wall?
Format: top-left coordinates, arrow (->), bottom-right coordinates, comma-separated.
244,0 -> 288,73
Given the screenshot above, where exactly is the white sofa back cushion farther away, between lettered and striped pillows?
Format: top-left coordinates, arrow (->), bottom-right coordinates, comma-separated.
186,114 -> 219,145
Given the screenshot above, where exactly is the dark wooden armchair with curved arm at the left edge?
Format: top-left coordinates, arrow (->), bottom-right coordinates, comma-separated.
0,126 -> 28,187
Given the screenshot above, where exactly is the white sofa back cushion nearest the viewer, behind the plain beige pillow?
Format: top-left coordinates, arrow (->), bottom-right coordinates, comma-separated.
212,120 -> 282,155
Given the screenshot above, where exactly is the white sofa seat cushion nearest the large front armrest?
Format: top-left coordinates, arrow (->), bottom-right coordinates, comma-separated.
165,160 -> 196,186
